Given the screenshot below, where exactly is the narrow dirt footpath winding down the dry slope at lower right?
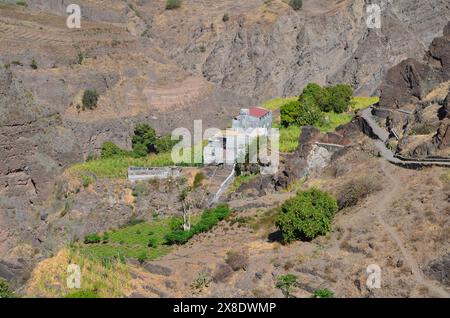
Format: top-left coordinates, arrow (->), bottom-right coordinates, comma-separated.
373,161 -> 450,298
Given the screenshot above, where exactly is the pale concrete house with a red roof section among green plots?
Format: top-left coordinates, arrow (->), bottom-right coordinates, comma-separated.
203,107 -> 272,165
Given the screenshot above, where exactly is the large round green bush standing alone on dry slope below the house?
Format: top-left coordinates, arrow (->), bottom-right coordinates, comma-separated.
276,189 -> 338,243
